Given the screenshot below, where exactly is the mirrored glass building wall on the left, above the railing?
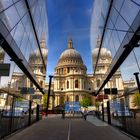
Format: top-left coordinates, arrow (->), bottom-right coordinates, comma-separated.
0,0 -> 48,107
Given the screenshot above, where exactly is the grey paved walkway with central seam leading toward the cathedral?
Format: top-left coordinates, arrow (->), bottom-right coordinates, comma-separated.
8,116 -> 137,140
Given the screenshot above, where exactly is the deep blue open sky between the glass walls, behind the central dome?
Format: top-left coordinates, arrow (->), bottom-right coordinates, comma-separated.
46,0 -> 93,81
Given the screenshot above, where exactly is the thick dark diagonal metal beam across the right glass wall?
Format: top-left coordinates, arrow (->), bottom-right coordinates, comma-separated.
96,12 -> 140,95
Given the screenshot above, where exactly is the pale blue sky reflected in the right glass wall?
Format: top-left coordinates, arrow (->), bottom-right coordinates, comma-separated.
90,0 -> 140,80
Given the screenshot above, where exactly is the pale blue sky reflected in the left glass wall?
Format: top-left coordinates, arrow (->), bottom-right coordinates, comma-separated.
0,0 -> 48,86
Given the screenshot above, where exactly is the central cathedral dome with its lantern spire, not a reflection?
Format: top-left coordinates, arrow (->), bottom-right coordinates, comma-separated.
57,38 -> 85,67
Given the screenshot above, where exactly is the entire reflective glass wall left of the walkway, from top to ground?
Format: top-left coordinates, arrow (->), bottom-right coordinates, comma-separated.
0,0 -> 48,138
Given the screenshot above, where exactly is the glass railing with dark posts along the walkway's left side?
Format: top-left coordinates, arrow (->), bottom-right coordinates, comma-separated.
0,93 -> 41,139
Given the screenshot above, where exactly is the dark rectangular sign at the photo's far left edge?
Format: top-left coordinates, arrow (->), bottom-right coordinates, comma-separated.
0,63 -> 10,76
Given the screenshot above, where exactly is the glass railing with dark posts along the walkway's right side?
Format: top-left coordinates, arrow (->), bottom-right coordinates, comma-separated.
96,91 -> 140,138
